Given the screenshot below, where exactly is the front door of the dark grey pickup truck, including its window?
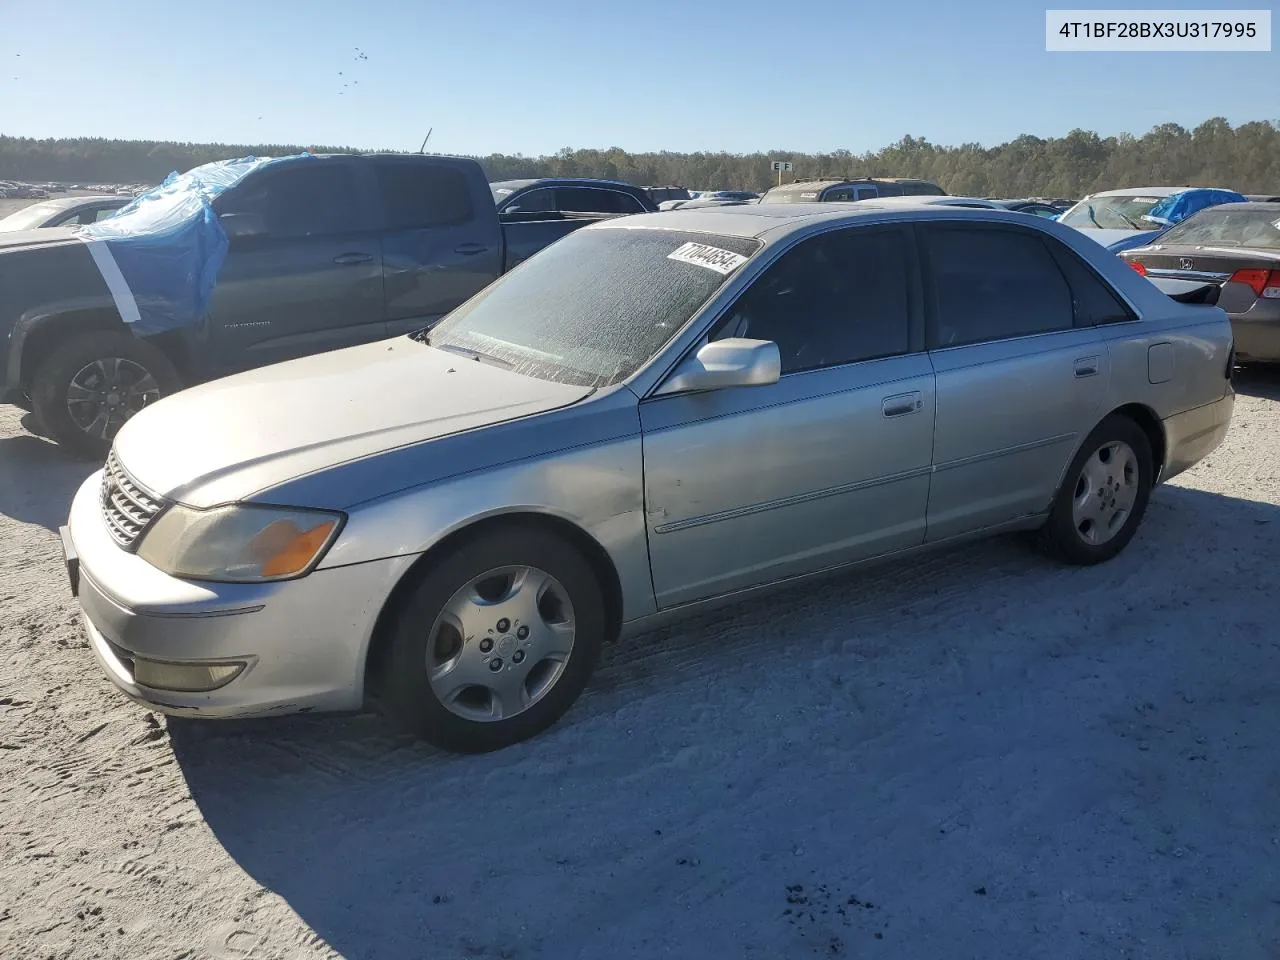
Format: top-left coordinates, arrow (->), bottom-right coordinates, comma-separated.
207,157 -> 385,372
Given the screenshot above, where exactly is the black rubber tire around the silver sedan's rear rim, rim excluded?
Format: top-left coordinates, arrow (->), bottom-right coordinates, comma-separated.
1039,415 -> 1155,566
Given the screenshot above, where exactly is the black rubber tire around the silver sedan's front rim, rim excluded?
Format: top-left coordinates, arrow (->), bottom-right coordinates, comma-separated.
372,522 -> 608,753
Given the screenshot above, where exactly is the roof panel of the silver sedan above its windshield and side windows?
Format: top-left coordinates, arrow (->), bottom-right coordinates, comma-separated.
582,197 -> 1051,239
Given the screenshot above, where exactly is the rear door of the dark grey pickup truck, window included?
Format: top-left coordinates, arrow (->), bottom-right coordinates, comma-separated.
372,156 -> 502,337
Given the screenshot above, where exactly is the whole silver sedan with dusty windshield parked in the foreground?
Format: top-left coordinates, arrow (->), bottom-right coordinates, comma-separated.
63,205 -> 1234,751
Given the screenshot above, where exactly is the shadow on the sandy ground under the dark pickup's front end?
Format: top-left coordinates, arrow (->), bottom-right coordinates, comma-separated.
0,434 -> 101,530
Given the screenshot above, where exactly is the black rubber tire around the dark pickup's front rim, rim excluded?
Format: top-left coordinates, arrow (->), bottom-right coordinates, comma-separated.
28,330 -> 182,460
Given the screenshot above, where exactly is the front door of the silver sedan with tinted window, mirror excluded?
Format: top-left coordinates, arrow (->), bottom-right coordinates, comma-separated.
640,228 -> 934,608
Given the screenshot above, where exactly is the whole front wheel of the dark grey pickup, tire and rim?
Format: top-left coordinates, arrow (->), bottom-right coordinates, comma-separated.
28,330 -> 182,460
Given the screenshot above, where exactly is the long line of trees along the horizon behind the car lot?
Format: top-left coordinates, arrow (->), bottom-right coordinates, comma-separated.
0,116 -> 1280,197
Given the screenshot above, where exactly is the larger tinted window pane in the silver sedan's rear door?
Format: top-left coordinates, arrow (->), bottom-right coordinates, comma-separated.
925,227 -> 1075,348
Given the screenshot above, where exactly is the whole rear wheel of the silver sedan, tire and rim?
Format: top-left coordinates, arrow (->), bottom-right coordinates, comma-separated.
1039,415 -> 1155,566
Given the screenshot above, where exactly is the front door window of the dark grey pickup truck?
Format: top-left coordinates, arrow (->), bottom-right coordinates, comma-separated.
218,161 -> 361,239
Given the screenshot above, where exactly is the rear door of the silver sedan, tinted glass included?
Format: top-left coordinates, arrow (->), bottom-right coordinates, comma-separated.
920,221 -> 1108,541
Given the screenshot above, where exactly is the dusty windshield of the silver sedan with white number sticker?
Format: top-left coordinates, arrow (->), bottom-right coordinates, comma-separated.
415,228 -> 759,387
